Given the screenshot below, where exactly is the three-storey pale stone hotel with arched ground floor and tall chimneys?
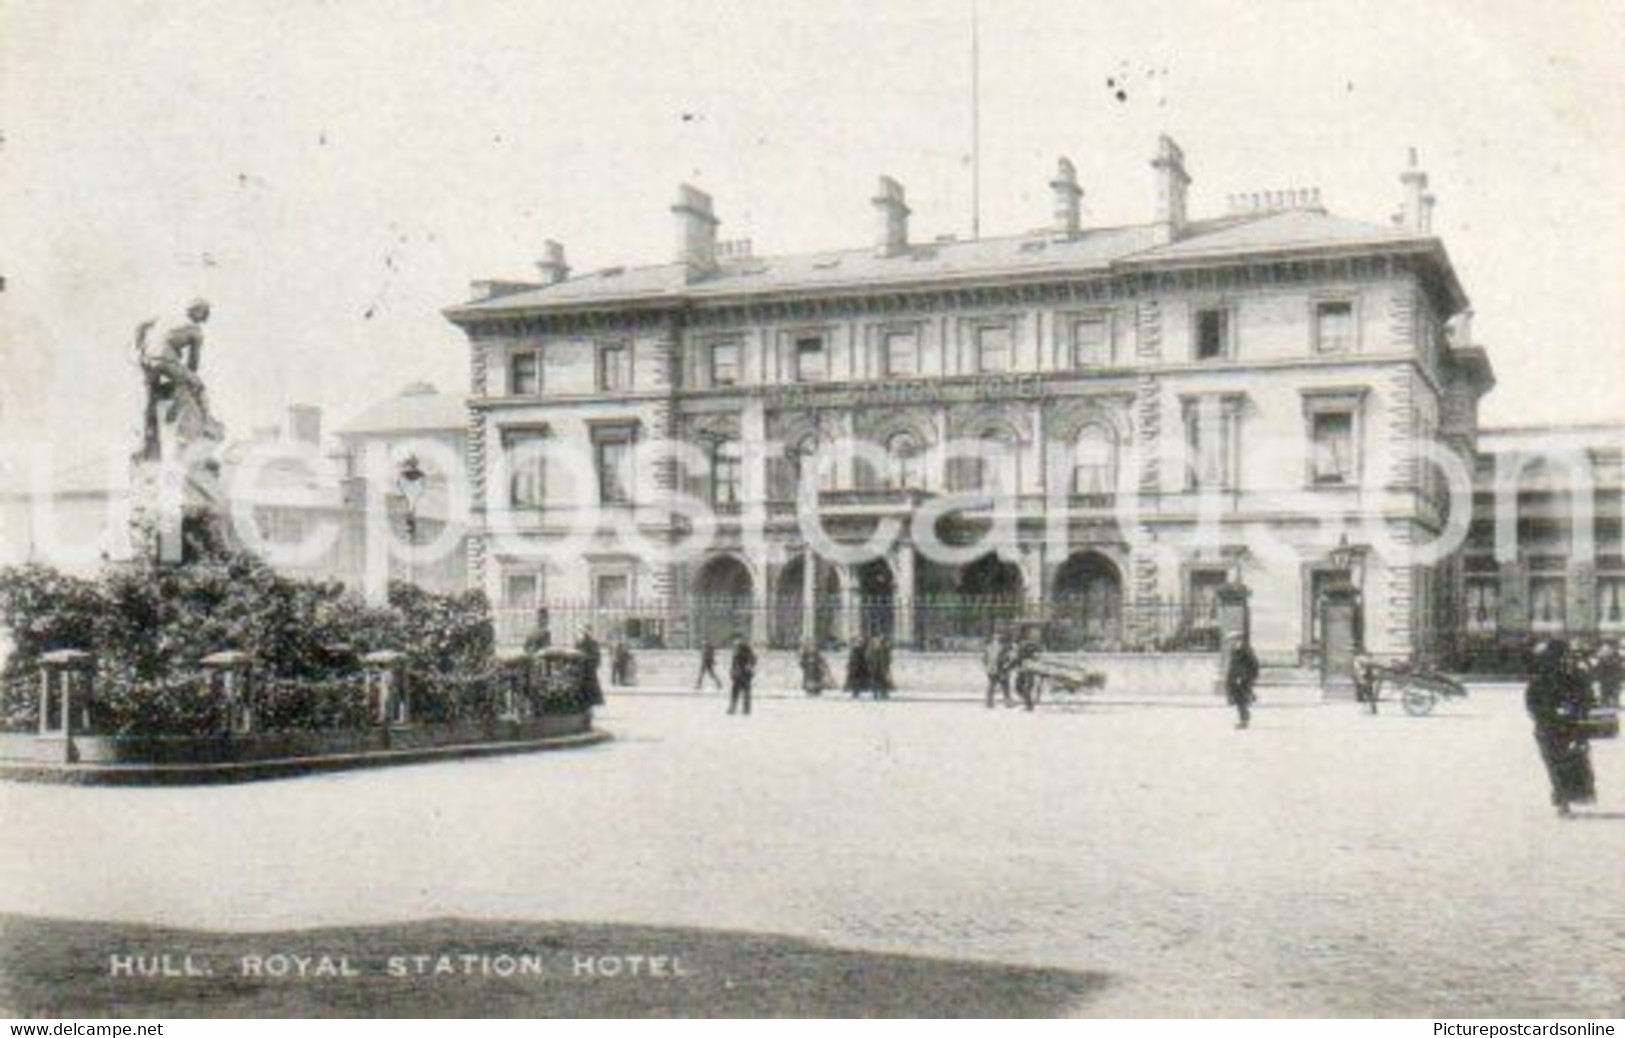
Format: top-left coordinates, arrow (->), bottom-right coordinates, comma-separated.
447,138 -> 1493,663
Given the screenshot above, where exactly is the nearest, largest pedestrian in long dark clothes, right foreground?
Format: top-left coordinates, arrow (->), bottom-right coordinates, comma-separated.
1524,638 -> 1597,817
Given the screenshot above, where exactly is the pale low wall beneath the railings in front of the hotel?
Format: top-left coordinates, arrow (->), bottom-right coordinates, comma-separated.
614,648 -> 1219,697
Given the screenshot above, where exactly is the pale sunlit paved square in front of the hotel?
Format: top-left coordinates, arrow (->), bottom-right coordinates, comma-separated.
0,690 -> 1625,1017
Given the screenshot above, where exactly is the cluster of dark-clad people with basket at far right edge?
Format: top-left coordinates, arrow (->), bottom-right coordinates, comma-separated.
1524,638 -> 1625,817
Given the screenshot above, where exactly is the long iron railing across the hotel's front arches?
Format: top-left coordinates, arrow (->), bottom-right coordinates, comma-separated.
494,596 -> 1219,651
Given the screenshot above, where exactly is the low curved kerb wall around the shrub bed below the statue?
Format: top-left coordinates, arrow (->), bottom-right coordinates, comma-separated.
0,711 -> 593,781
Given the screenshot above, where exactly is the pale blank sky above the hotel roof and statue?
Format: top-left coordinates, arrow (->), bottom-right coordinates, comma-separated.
0,0 -> 1625,456
